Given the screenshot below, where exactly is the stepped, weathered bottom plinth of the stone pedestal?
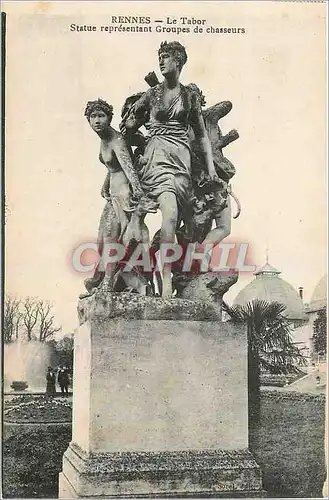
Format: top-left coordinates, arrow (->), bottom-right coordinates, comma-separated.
59,443 -> 263,498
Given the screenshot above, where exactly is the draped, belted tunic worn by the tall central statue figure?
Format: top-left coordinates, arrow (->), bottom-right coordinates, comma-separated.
139,87 -> 191,207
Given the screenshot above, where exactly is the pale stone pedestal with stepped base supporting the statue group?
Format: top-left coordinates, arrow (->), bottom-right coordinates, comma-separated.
59,292 -> 262,498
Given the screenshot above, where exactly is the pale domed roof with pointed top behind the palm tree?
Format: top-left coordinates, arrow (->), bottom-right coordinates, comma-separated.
234,263 -> 307,320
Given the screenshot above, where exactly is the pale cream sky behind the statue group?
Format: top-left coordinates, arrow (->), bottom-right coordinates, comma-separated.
3,2 -> 327,333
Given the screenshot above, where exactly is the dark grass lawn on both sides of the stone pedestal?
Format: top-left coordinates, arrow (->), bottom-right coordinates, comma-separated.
3,391 -> 325,498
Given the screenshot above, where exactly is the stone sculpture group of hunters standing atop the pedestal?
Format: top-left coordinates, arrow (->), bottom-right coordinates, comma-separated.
81,42 -> 240,298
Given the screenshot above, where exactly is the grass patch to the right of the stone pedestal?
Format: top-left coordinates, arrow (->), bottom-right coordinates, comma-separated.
249,391 -> 325,498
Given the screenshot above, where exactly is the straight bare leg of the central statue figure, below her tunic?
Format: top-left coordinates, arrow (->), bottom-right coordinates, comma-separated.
158,192 -> 178,298
